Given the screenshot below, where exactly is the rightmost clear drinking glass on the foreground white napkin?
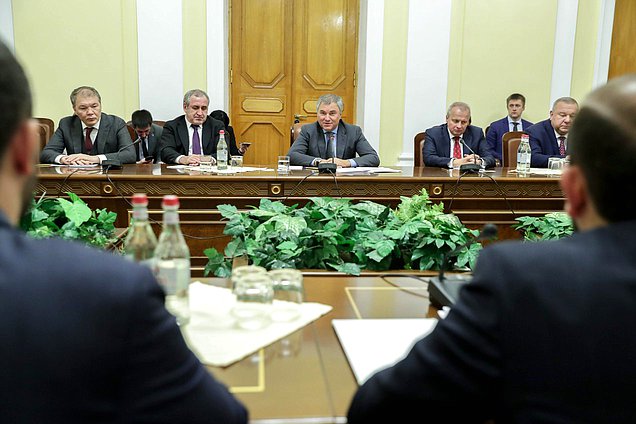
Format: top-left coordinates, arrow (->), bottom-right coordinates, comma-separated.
268,268 -> 304,322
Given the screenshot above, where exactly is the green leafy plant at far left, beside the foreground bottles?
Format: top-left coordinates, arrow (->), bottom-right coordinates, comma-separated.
20,193 -> 117,248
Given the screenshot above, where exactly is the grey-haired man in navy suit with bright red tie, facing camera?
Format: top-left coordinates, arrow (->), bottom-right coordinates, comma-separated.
422,102 -> 495,168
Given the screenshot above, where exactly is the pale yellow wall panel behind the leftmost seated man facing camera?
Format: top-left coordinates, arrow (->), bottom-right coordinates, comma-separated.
13,0 -> 139,122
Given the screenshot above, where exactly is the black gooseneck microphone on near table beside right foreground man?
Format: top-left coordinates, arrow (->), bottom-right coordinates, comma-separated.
428,223 -> 497,306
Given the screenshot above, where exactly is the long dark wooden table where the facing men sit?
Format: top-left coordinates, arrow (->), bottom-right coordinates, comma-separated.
36,164 -> 564,276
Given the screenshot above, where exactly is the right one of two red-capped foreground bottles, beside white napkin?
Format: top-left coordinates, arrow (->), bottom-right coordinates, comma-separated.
155,195 -> 190,325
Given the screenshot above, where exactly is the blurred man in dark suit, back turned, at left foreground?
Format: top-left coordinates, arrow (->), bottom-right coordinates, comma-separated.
0,43 -> 247,424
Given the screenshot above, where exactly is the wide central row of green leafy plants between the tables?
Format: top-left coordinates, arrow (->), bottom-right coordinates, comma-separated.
204,190 -> 481,277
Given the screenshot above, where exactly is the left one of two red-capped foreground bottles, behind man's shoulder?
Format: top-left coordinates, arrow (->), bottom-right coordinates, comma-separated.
124,193 -> 157,271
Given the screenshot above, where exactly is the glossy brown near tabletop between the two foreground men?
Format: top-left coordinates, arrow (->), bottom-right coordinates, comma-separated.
204,273 -> 437,424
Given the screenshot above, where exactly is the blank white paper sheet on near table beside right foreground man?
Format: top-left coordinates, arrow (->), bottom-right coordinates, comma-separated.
331,318 -> 437,384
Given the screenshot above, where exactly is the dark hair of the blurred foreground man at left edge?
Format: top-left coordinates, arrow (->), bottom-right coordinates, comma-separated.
0,42 -> 32,157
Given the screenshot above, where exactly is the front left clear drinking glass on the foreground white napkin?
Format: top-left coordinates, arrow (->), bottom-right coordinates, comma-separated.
232,273 -> 274,330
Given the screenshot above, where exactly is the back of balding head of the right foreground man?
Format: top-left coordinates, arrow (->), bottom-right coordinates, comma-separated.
568,74 -> 636,222
